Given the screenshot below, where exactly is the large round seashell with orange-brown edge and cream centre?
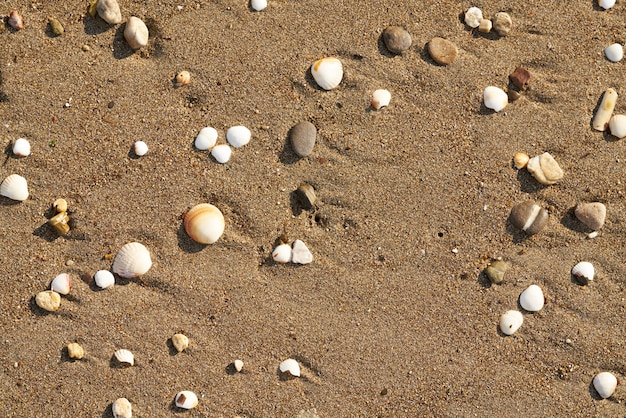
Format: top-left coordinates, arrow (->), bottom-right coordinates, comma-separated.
183,203 -> 225,244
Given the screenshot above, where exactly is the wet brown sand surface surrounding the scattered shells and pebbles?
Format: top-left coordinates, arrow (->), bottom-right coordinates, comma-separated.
0,0 -> 626,417
